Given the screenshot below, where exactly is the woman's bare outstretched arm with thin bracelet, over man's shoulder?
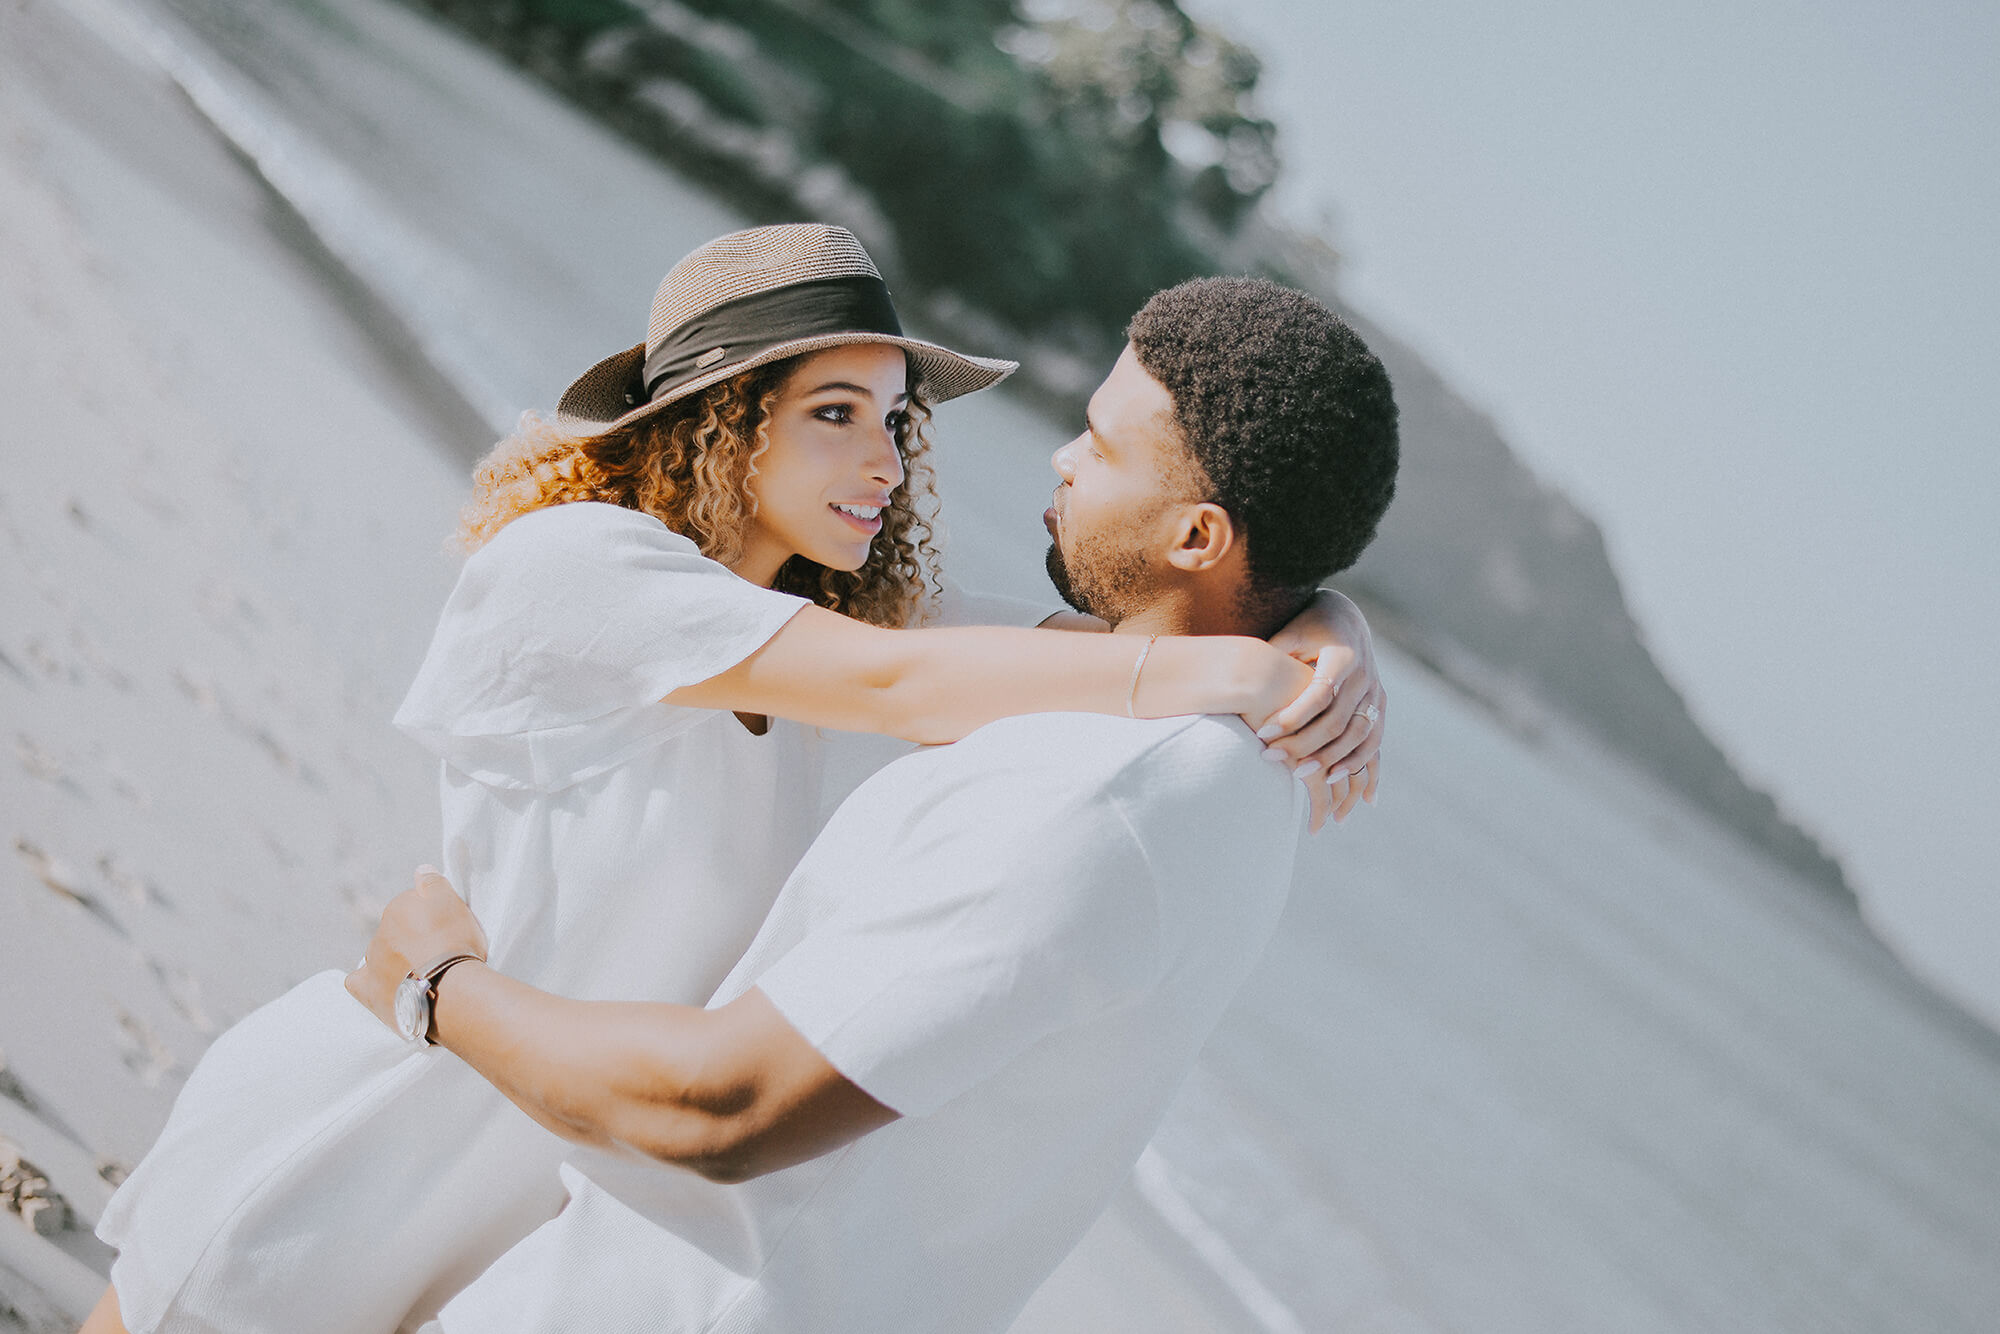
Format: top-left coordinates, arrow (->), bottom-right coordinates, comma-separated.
666,606 -> 1318,742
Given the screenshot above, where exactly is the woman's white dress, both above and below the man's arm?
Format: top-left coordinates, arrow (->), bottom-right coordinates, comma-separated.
98,504 -> 820,1334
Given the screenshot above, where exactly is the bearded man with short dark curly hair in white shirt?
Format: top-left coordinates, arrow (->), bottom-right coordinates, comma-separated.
350,278 -> 1396,1334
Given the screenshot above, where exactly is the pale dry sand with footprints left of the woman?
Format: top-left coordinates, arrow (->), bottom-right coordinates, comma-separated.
0,4 -> 462,1308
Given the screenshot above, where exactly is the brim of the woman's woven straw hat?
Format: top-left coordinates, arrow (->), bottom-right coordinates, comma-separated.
556,330 -> 1020,432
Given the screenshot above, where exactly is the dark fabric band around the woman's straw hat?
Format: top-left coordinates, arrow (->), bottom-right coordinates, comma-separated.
644,274 -> 902,402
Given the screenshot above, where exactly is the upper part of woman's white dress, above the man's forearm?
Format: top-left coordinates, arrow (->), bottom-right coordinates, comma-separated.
396,504 -> 820,1000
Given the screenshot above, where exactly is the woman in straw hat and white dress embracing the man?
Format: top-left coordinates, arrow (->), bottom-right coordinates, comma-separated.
86,226 -> 1384,1332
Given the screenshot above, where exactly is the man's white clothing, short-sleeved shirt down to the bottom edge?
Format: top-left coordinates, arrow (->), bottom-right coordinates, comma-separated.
442,714 -> 1304,1334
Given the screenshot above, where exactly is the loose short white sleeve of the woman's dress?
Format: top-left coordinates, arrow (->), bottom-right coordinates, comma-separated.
396,502 -> 804,790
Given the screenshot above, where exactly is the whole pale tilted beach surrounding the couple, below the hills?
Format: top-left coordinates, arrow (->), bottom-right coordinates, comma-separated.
0,0 -> 2000,1334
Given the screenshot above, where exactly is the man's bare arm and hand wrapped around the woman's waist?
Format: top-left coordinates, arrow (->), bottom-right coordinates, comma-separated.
348,872 -> 896,1182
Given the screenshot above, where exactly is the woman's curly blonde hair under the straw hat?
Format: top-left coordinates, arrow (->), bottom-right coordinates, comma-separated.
456,358 -> 940,626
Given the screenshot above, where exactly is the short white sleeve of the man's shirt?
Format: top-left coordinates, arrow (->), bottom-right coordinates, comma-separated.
746,774 -> 1160,1116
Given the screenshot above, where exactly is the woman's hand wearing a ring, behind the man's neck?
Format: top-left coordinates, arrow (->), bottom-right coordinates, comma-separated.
1260,588 -> 1388,830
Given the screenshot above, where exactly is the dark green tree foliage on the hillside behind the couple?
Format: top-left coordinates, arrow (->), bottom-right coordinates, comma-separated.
420,0 -> 1276,354
